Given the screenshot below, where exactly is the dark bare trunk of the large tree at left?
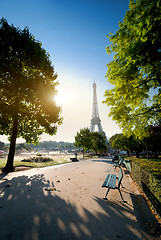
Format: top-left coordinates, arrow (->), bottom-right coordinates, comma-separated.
2,118 -> 18,172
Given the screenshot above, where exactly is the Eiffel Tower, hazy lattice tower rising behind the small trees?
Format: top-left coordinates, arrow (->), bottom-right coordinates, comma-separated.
89,82 -> 106,136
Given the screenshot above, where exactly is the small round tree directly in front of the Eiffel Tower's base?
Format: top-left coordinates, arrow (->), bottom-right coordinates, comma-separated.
91,132 -> 107,155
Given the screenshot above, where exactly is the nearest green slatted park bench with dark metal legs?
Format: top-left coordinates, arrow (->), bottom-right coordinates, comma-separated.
102,167 -> 124,202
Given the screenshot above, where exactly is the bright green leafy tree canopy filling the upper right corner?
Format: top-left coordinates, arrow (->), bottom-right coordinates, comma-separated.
104,0 -> 161,138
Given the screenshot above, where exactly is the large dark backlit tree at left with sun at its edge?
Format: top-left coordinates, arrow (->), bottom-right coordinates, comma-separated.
0,19 -> 62,171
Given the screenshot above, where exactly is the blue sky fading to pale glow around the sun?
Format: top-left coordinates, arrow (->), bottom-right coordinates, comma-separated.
0,0 -> 129,143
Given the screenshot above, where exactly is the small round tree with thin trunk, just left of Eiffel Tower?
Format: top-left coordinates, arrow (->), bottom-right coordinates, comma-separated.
74,128 -> 92,159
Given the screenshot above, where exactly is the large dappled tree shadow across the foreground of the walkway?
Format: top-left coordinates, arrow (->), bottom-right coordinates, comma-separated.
0,174 -> 160,240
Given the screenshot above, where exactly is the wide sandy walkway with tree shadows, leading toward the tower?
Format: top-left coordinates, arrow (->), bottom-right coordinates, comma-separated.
0,158 -> 160,240
